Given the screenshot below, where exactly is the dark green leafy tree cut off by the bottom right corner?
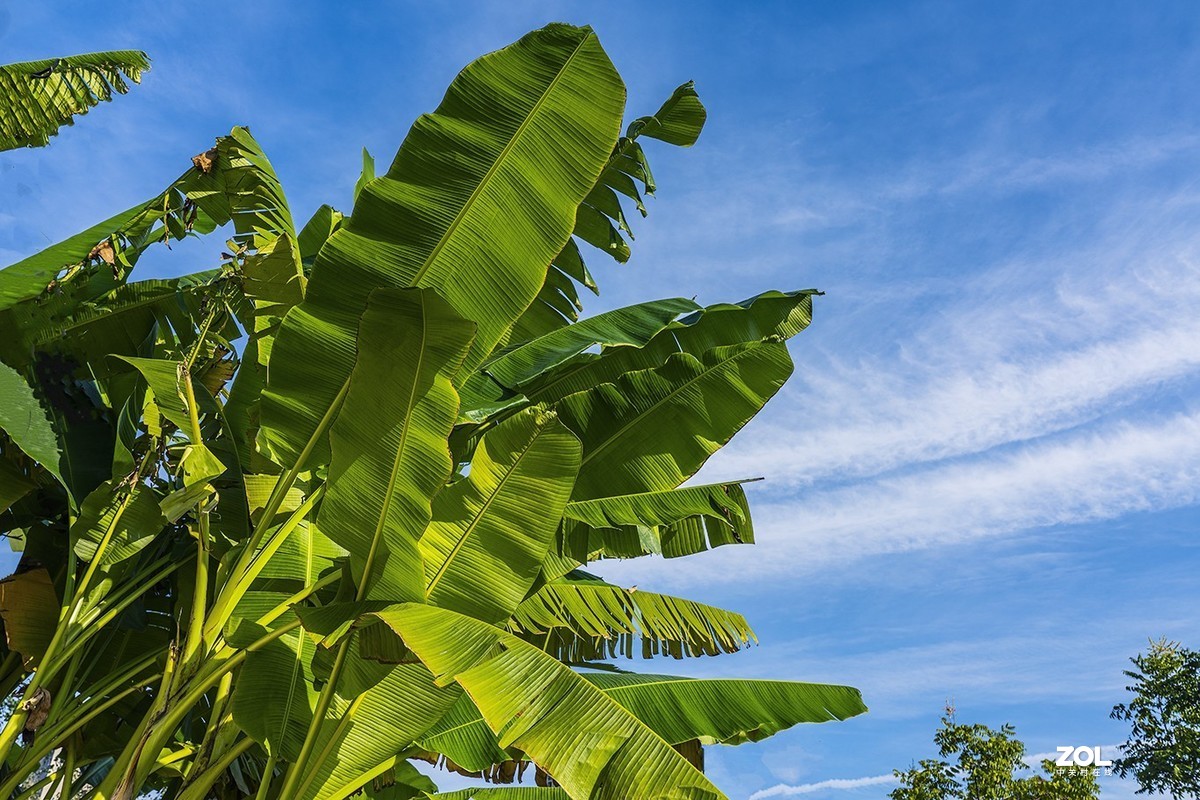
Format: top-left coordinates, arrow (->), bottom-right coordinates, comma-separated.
1112,638 -> 1200,798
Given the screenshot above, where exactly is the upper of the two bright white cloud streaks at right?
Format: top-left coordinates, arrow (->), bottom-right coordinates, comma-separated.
718,320 -> 1200,483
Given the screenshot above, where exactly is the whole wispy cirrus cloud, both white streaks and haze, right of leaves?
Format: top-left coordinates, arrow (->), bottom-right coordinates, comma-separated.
604,176 -> 1200,585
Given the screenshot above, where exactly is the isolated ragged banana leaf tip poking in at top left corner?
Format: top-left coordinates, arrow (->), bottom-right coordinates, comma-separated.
0,50 -> 150,151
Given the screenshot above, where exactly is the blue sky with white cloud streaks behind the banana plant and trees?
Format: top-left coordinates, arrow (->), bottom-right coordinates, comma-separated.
0,0 -> 1200,800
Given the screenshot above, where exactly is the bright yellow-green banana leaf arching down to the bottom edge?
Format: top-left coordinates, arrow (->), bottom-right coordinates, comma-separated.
378,603 -> 725,800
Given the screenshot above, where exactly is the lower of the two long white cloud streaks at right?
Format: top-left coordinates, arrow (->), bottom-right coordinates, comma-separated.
605,413 -> 1200,587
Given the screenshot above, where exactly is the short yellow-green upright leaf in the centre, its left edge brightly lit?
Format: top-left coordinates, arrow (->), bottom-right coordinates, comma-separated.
420,409 -> 580,622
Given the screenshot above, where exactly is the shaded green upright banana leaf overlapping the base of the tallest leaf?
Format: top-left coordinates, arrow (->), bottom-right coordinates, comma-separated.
319,289 -> 474,601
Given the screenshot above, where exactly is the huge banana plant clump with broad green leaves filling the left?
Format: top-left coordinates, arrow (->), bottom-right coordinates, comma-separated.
0,25 -> 866,800
